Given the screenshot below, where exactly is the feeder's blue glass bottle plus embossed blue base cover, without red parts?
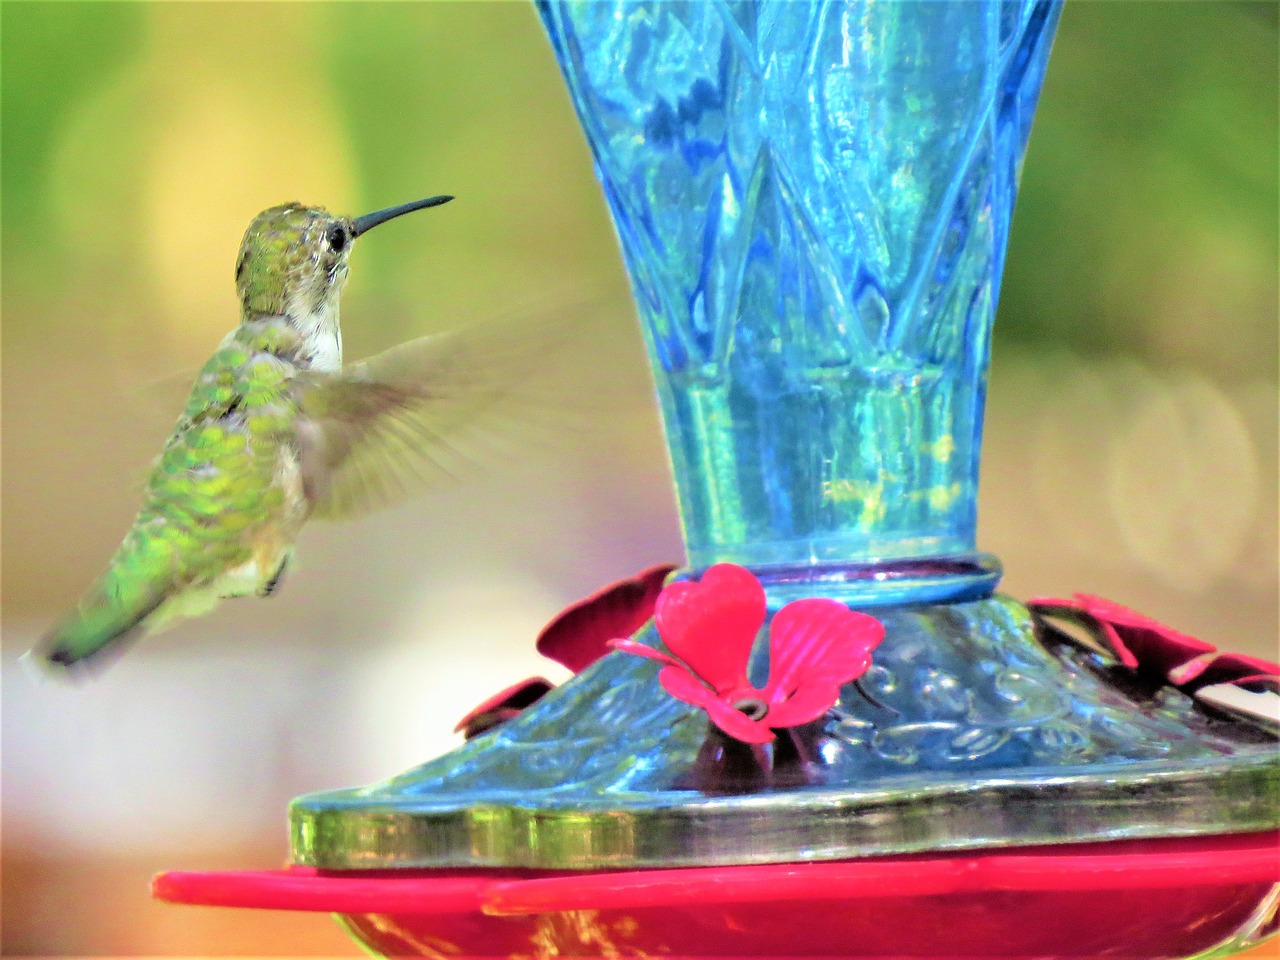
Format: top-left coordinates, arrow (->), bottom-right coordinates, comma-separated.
291,0 -> 1280,869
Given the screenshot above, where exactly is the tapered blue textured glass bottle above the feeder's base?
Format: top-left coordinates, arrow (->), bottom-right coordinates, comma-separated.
540,0 -> 1059,600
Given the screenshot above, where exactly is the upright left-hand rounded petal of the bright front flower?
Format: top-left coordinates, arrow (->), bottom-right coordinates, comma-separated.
654,563 -> 764,692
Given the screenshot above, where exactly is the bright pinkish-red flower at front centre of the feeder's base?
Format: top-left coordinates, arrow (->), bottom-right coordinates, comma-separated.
612,563 -> 884,744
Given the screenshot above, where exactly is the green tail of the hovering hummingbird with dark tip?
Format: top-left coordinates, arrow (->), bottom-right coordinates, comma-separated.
23,571 -> 166,675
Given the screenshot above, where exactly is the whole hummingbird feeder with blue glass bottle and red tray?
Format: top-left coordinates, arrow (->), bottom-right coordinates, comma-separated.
155,0 -> 1280,957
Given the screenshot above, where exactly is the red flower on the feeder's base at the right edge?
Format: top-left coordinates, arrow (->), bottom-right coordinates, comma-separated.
1027,594 -> 1280,692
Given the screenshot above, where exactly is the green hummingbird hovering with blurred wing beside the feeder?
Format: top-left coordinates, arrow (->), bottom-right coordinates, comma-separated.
27,196 -> 535,671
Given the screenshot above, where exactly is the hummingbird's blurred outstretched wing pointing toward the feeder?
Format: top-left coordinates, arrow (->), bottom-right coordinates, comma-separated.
297,313 -> 573,518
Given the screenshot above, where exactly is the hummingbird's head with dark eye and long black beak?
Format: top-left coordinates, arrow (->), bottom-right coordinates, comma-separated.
236,197 -> 453,317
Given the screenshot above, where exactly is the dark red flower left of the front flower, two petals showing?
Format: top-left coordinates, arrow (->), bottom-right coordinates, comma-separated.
454,563 -> 676,740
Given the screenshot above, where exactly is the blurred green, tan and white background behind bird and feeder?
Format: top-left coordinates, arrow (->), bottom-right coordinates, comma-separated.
0,0 -> 1280,954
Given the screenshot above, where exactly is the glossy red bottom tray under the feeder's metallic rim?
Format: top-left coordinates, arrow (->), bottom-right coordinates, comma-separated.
152,832 -> 1280,960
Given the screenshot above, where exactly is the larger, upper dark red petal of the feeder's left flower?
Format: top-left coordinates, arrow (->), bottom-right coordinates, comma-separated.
538,563 -> 676,673
